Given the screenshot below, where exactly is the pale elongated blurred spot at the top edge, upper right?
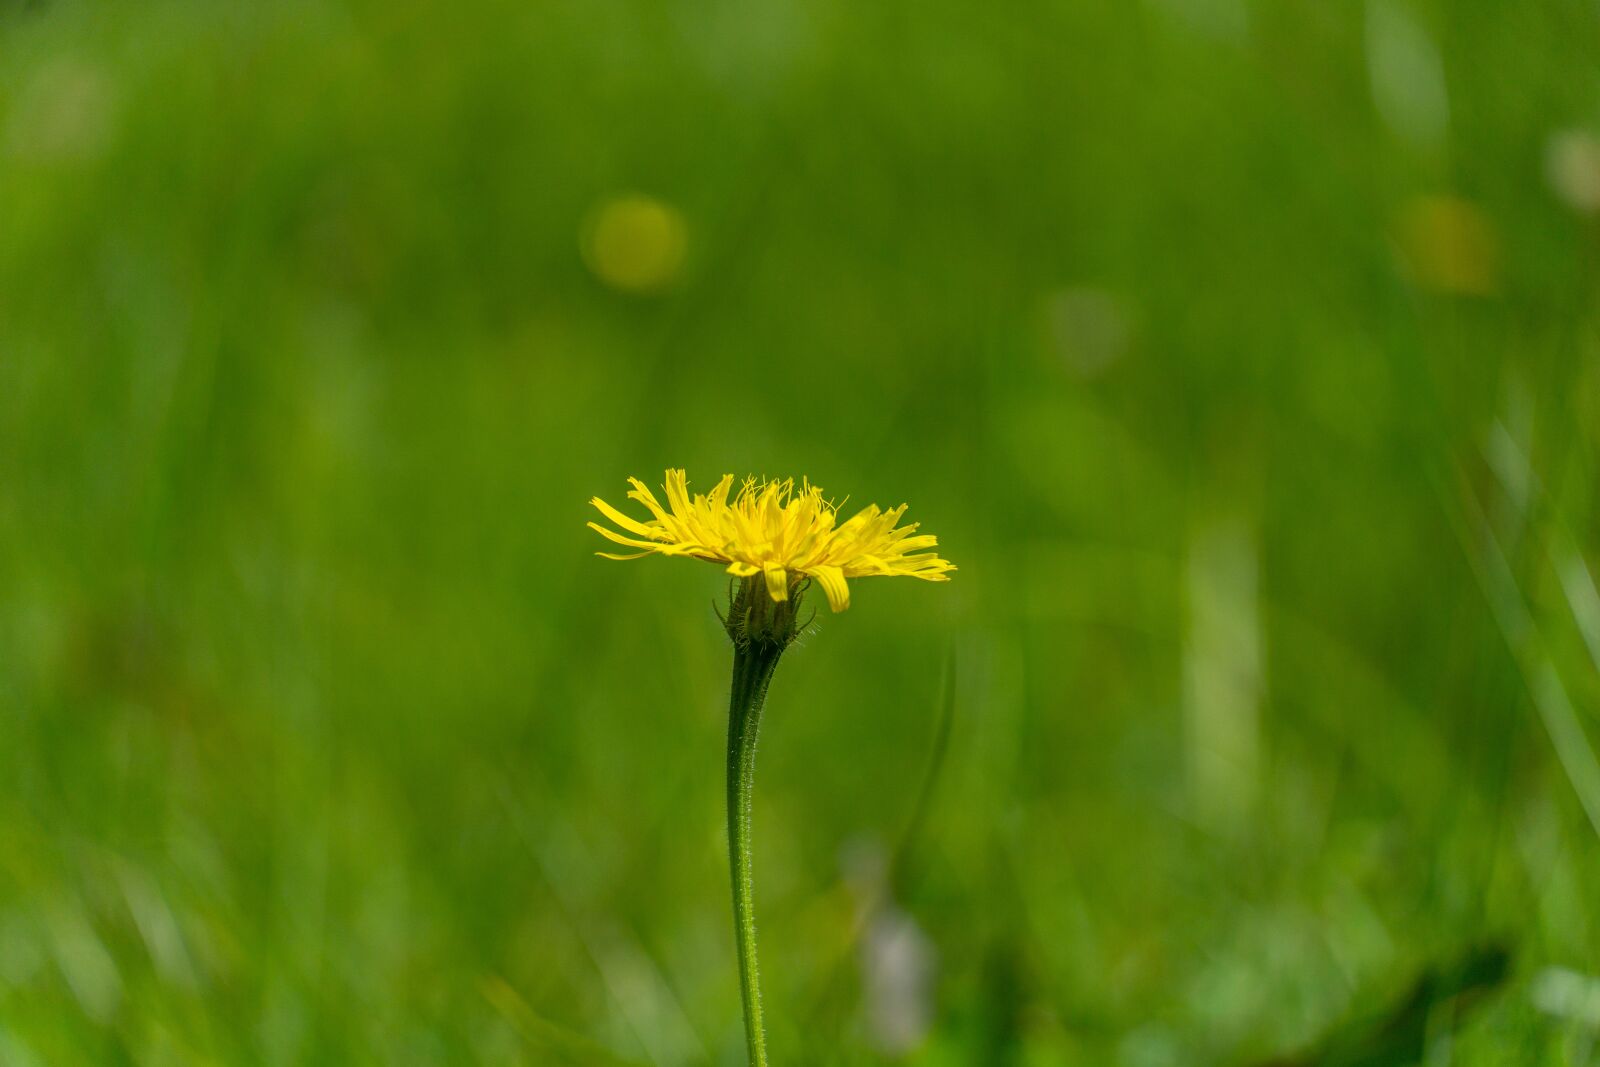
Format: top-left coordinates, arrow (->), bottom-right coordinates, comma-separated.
1366,0 -> 1450,149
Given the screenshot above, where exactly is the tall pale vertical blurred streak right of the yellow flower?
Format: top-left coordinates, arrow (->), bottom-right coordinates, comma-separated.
1184,518 -> 1262,825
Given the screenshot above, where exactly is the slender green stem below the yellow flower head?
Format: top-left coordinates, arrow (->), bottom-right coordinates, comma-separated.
728,640 -> 784,1067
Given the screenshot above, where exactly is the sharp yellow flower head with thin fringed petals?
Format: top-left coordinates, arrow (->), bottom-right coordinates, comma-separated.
589,470 -> 955,611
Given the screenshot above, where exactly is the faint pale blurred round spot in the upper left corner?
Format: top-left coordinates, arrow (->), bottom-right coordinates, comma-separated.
5,59 -> 112,163
